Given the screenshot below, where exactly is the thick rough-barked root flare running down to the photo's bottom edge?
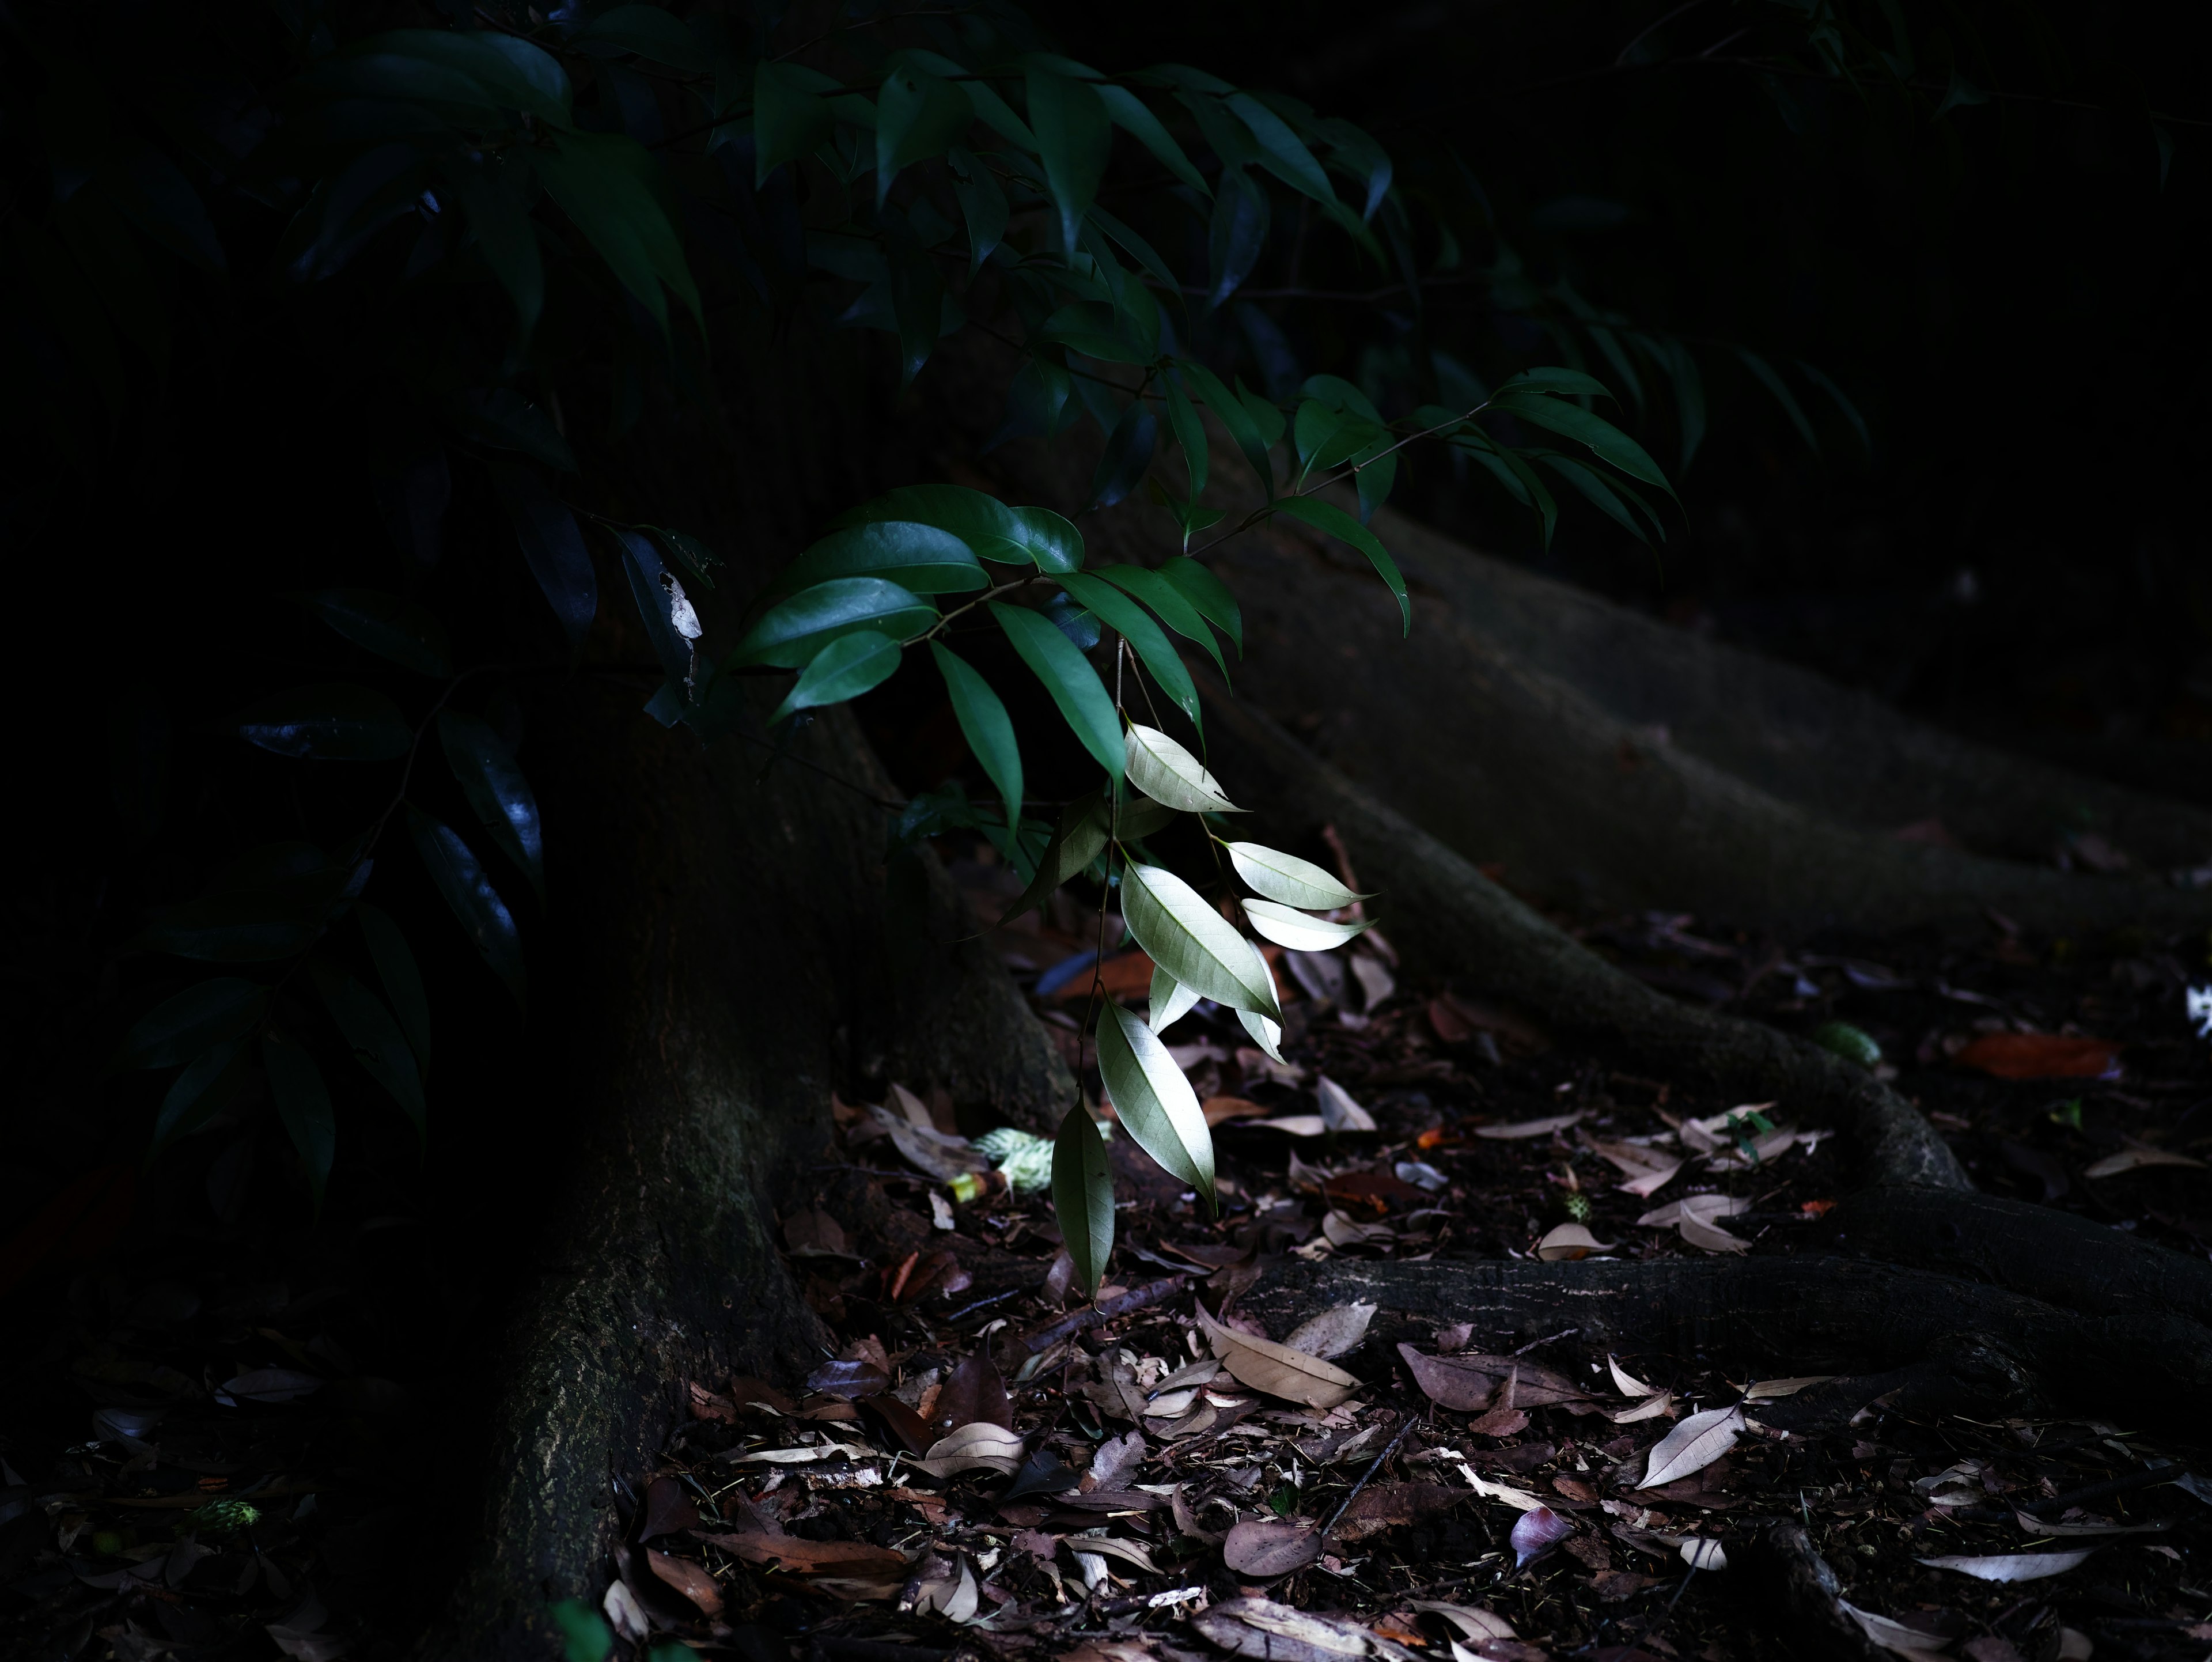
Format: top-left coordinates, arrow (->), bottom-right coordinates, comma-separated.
435,686 -> 1073,1662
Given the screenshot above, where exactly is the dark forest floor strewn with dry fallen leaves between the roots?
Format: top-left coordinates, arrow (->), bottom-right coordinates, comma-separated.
0,850 -> 2212,1662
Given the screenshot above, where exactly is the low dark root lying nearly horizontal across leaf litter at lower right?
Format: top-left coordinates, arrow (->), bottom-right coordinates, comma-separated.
1245,1255 -> 2212,1425
